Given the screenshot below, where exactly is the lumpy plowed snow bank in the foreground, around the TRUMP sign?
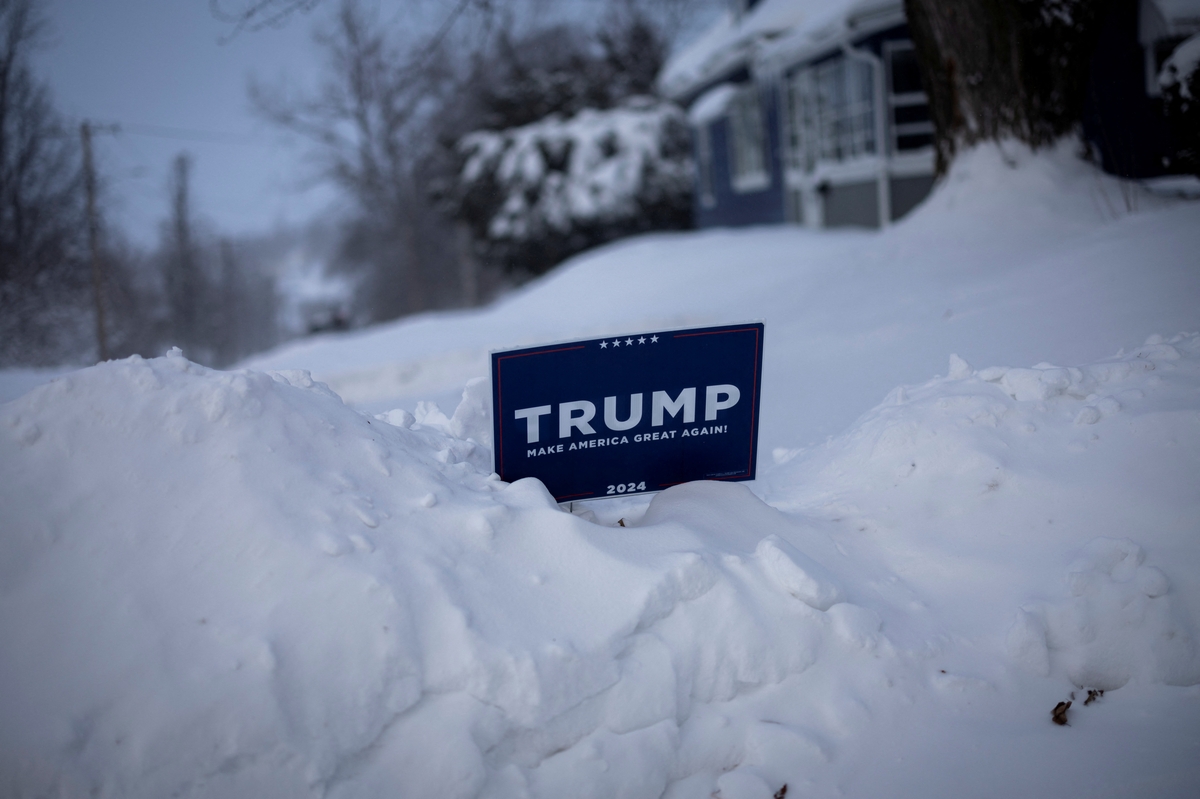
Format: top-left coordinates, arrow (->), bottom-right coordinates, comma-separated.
0,328 -> 1200,798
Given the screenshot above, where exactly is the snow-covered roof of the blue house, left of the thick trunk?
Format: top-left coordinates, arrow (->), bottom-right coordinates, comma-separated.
659,0 -> 902,100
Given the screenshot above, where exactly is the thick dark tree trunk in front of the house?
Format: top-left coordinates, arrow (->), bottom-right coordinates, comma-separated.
905,0 -> 1111,174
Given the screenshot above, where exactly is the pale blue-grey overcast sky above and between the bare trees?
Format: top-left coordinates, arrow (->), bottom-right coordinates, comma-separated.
37,0 -> 710,245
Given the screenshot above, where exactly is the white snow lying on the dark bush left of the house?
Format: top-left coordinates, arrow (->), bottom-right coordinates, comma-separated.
460,97 -> 692,241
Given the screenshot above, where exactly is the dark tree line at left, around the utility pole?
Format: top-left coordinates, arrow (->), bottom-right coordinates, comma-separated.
0,0 -> 296,367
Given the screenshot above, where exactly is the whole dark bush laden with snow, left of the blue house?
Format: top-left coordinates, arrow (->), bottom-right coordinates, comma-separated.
456,97 -> 692,274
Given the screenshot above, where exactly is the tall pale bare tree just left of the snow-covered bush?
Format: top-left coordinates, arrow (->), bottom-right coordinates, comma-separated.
251,0 -> 451,319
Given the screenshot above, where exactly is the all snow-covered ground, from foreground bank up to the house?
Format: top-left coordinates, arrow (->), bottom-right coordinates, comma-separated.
7,146 -> 1200,799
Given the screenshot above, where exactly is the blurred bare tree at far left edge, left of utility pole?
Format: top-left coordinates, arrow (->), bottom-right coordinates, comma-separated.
0,0 -> 91,364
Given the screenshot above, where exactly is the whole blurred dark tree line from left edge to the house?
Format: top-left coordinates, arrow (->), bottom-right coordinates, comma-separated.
0,0 -> 686,366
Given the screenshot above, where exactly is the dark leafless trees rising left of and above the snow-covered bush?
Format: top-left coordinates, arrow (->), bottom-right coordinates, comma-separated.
247,0 -> 713,323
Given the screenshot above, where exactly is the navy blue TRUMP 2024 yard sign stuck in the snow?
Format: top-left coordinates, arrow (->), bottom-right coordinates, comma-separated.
492,323 -> 763,501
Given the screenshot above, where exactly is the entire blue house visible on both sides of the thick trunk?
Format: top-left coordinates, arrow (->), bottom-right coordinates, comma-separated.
659,0 -> 1200,228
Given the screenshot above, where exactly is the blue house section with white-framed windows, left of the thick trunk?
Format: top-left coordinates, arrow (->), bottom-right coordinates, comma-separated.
659,0 -> 934,228
